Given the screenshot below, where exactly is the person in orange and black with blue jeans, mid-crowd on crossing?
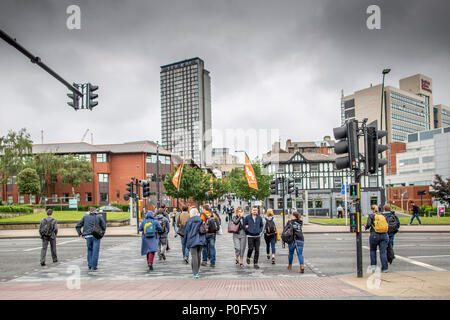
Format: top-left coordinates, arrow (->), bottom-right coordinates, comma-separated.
200,204 -> 220,268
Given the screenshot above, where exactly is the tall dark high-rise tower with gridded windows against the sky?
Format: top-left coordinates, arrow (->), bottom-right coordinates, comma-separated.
160,58 -> 212,167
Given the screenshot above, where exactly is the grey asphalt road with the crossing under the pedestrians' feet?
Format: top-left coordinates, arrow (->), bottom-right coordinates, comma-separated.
0,233 -> 450,282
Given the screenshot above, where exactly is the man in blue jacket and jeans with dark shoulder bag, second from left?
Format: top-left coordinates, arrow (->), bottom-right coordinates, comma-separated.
75,207 -> 106,271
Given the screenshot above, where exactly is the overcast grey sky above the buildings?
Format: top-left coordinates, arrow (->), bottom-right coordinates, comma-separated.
0,0 -> 450,157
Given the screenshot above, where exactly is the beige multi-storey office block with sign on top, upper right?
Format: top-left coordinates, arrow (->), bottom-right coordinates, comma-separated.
341,74 -> 450,143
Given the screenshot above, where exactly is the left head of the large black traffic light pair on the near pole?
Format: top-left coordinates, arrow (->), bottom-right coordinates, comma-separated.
333,120 -> 359,170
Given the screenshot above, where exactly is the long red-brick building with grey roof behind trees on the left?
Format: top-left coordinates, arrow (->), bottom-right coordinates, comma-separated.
1,141 -> 182,208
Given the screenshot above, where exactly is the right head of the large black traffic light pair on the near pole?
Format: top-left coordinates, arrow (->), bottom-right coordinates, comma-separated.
364,120 -> 388,174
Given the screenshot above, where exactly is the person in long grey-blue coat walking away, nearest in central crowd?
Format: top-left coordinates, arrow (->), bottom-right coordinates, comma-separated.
182,208 -> 206,279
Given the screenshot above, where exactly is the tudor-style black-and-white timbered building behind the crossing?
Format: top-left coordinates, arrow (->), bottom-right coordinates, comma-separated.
263,148 -> 381,217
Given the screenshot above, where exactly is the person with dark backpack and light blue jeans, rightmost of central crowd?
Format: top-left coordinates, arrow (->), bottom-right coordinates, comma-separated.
283,211 -> 305,273
